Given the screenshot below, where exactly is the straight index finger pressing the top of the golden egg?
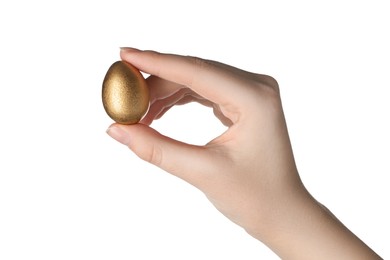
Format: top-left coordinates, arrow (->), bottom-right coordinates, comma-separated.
121,48 -> 253,106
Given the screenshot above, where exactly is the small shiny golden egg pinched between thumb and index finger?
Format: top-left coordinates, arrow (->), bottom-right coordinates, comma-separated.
102,61 -> 149,125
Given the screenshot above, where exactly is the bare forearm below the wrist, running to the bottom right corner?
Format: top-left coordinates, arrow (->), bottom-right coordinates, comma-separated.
250,190 -> 382,260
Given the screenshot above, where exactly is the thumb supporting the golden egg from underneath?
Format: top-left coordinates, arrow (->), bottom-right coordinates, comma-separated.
107,124 -> 215,187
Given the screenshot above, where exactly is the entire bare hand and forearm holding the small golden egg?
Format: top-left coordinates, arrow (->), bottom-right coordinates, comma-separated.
107,48 -> 381,260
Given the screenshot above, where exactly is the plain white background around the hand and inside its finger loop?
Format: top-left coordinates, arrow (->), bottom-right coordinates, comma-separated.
0,0 -> 390,260
